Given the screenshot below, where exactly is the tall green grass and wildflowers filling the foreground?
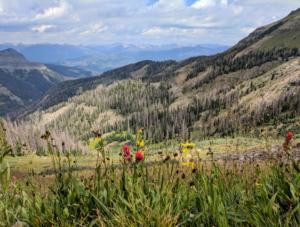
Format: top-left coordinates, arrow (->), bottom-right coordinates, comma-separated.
0,127 -> 300,226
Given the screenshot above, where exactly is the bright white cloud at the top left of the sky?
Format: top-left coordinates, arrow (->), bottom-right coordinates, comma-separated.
34,2 -> 69,20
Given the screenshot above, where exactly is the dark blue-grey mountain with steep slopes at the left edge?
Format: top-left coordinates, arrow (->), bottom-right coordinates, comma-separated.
0,48 -> 91,116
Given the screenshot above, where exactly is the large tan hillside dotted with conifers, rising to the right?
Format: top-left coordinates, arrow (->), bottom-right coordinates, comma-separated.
15,9 -> 300,142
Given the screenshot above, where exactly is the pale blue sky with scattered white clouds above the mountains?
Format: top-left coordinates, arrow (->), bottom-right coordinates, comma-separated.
0,0 -> 300,46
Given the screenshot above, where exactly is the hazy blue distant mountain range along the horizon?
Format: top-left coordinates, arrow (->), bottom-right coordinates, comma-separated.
0,44 -> 229,74
